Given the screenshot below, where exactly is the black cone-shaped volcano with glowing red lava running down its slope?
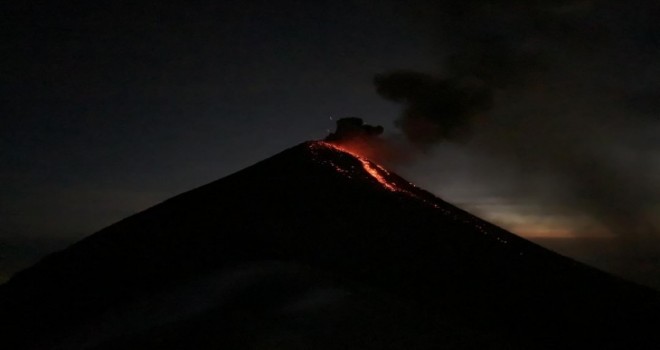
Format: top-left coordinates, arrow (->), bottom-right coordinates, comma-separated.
0,141 -> 660,350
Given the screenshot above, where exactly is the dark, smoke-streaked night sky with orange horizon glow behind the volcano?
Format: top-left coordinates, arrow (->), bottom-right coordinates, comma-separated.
0,0 -> 660,288
